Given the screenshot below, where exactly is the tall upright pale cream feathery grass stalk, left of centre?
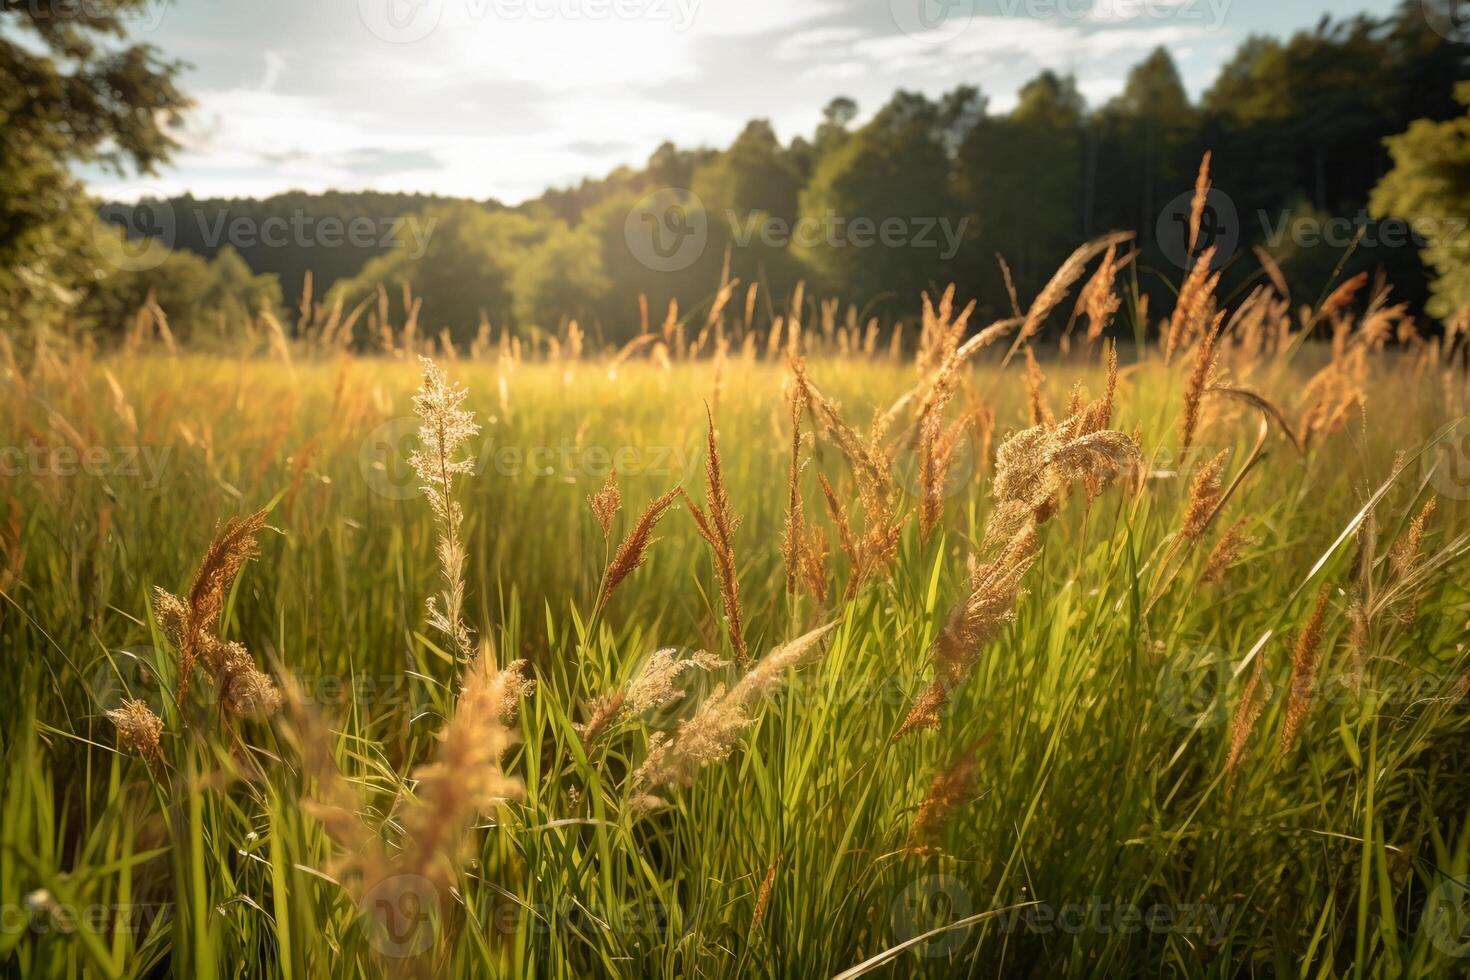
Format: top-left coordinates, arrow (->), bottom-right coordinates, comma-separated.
409,357 -> 479,663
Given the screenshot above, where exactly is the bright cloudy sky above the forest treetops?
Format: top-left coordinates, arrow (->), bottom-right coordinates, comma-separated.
85,0 -> 1394,203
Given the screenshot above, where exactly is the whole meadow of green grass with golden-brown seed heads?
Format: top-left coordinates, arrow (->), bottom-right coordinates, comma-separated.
0,270 -> 1470,977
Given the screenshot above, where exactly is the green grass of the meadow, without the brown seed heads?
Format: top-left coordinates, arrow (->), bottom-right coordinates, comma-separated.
0,348 -> 1470,979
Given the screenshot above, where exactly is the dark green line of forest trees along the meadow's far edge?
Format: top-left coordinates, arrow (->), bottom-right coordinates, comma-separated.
0,0 -> 1470,342
